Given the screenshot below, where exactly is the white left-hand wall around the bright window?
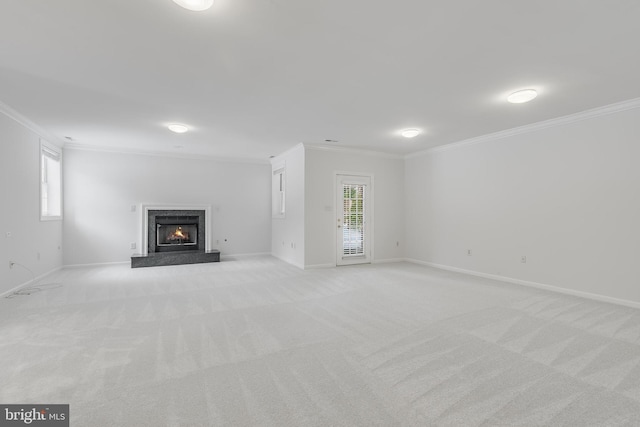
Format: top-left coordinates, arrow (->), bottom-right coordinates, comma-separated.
0,113 -> 64,294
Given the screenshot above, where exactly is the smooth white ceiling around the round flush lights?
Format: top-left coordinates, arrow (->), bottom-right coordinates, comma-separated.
0,0 -> 640,160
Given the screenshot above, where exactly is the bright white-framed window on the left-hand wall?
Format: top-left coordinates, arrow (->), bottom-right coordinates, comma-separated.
40,141 -> 62,221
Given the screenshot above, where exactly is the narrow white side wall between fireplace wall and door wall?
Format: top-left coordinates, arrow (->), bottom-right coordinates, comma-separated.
271,144 -> 305,268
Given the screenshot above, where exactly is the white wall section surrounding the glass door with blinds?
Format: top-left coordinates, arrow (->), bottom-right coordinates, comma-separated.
305,146 -> 405,267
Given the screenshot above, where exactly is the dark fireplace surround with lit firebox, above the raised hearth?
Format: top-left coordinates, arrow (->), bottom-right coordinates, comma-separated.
147,209 -> 206,253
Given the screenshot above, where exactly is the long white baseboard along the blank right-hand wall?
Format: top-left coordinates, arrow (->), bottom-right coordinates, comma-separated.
405,258 -> 640,308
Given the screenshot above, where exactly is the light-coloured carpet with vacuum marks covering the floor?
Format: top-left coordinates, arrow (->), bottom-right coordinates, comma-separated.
0,257 -> 640,426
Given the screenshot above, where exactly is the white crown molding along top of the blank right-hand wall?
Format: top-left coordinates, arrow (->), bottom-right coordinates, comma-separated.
404,98 -> 640,159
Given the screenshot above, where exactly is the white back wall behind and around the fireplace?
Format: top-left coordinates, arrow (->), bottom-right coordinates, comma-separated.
64,150 -> 271,265
